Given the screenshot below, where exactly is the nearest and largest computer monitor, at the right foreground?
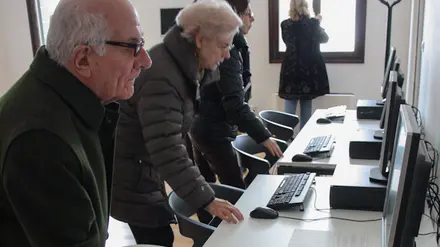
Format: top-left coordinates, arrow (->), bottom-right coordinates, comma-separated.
382,105 -> 431,247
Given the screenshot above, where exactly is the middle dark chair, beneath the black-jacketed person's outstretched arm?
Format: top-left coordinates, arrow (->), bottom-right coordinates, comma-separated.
232,134 -> 287,186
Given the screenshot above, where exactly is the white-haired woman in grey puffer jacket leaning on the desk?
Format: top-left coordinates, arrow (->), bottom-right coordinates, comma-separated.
112,0 -> 243,246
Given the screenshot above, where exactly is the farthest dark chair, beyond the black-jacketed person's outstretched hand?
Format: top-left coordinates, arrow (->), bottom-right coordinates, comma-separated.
259,110 -> 299,142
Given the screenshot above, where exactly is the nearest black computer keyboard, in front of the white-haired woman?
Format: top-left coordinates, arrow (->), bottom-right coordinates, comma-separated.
267,172 -> 316,210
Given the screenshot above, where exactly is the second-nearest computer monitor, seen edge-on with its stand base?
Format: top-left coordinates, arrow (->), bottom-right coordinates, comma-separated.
370,71 -> 402,184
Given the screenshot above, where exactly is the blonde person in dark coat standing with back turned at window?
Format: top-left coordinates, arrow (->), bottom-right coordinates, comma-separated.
278,0 -> 330,128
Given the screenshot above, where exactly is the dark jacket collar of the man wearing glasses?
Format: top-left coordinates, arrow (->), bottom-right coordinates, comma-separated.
30,46 -> 104,131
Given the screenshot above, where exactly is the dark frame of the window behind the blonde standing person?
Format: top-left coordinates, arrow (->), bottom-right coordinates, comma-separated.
269,0 -> 367,63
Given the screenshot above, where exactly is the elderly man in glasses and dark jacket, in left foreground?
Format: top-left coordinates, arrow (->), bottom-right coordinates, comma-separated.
0,0 -> 151,247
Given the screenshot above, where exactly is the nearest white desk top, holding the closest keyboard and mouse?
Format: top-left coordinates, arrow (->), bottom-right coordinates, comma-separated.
204,175 -> 436,247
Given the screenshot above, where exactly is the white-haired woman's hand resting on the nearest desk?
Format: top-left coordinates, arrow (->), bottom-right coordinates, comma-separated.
206,198 -> 243,224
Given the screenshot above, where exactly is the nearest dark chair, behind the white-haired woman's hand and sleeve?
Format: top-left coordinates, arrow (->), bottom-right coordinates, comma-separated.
168,183 -> 244,247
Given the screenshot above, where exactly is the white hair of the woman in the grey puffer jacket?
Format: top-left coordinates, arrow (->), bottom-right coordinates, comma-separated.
176,0 -> 243,41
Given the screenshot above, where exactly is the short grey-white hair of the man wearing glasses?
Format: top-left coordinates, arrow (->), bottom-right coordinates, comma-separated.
46,0 -> 112,66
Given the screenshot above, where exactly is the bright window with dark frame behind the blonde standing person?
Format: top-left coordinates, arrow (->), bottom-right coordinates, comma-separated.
269,0 -> 367,63
